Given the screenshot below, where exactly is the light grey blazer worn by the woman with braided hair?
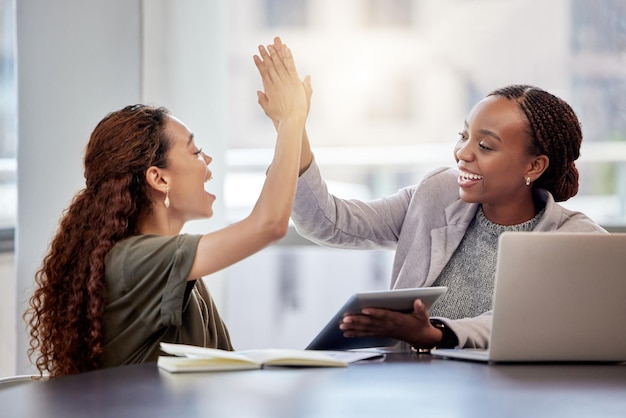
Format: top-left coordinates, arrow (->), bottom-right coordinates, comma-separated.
291,161 -> 606,349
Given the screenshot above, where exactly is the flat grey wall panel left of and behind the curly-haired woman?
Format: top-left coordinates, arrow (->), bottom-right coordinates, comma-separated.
16,0 -> 141,373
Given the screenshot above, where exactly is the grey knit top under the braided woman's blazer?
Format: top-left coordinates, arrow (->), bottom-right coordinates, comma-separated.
430,206 -> 544,319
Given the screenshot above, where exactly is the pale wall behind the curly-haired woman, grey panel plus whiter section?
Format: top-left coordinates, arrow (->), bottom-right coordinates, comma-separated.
15,0 -> 226,373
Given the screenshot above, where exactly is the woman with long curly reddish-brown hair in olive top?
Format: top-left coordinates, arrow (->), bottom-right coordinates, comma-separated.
25,39 -> 311,377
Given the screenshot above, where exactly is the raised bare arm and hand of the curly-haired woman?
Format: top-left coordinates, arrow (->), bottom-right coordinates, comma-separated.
189,38 -> 311,280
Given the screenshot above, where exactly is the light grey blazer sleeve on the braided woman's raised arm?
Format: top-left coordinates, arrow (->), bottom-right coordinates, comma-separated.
291,156 -> 411,249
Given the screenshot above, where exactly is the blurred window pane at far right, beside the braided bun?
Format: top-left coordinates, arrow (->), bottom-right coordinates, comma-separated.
570,0 -> 626,220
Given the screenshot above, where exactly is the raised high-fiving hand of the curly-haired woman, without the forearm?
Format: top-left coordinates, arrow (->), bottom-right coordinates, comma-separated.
254,37 -> 312,128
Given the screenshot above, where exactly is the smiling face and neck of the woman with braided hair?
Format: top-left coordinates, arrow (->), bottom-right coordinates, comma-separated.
454,96 -> 541,224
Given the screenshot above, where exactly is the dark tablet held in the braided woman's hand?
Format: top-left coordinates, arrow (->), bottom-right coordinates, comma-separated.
306,286 -> 448,350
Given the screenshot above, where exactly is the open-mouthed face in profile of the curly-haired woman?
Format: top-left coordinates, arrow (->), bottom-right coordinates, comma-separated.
162,112 -> 215,222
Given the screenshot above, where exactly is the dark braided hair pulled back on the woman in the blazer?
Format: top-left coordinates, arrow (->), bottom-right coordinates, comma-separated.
488,85 -> 583,202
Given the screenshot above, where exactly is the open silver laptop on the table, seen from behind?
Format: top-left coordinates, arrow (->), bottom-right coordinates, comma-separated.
431,232 -> 626,362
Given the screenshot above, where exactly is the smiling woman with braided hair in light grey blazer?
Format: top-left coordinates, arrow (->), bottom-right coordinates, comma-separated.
282,85 -> 606,349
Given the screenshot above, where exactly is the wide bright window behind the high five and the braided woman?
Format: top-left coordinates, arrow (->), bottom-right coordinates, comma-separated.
227,0 -> 626,225
